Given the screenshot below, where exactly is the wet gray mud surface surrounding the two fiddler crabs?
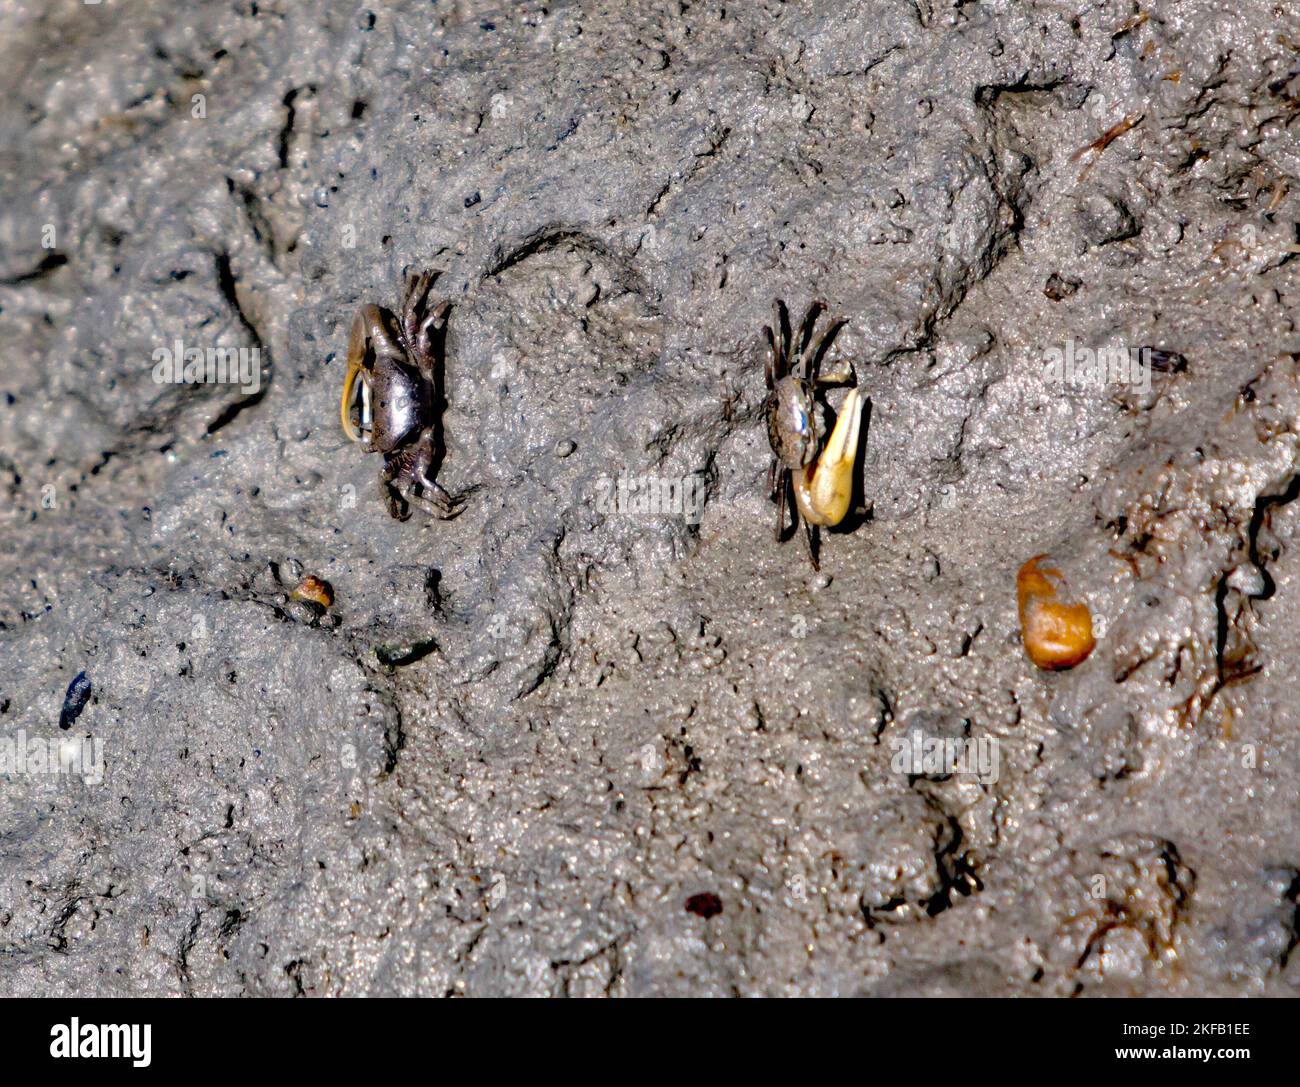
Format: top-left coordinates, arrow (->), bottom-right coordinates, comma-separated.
0,0 -> 1300,996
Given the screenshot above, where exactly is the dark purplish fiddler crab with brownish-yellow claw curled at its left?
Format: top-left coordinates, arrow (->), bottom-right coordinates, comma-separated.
339,272 -> 464,521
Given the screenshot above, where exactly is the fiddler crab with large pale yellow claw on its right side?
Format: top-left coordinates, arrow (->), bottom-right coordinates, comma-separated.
763,299 -> 863,570
